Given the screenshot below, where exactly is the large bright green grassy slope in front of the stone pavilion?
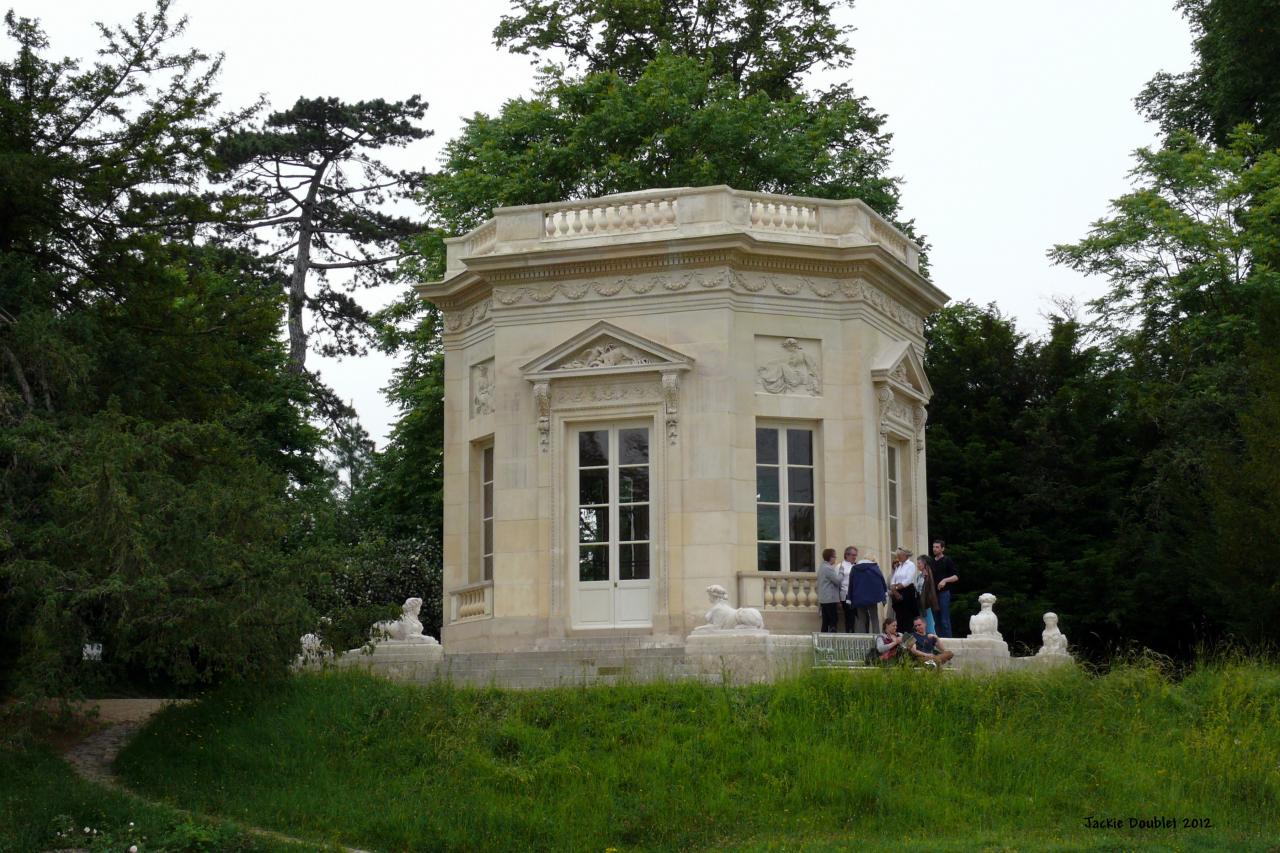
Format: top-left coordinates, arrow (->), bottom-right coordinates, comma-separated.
118,665 -> 1280,850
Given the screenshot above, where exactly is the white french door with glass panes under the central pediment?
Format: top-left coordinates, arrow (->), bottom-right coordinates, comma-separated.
567,424 -> 653,628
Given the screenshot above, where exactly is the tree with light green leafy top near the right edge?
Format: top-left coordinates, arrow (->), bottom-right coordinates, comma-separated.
1052,127 -> 1280,651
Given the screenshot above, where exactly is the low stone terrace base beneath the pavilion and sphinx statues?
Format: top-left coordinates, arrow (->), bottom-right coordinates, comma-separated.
322,631 -> 1071,689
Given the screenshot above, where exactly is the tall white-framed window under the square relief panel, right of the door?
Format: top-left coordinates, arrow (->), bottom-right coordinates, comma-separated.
755,427 -> 818,571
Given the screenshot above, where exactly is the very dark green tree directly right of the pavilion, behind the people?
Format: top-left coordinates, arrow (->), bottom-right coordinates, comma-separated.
925,302 -> 1133,651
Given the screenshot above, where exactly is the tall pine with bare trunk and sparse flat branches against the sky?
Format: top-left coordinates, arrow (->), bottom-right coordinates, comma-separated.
218,95 -> 430,373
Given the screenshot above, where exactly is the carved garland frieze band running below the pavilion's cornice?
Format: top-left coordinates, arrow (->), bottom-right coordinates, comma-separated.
486,270 -> 924,334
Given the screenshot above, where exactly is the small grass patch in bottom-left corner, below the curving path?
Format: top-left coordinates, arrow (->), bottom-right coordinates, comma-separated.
0,744 -> 320,853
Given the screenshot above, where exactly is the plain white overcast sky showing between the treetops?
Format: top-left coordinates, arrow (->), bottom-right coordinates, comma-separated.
27,0 -> 1192,446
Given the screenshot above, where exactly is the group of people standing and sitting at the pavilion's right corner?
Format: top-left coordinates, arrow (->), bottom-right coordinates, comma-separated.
818,539 -> 960,666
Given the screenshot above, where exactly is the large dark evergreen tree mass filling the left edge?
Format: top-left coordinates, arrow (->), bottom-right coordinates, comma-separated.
0,1 -> 326,694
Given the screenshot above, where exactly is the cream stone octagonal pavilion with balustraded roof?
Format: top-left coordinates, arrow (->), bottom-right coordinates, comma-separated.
416,187 -> 947,652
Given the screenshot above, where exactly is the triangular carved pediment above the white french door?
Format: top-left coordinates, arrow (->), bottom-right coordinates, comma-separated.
521,320 -> 694,380
